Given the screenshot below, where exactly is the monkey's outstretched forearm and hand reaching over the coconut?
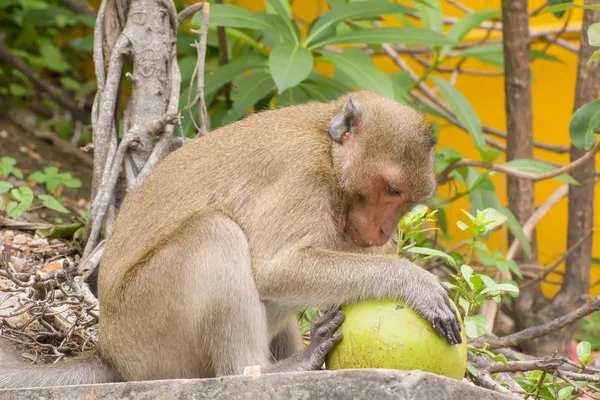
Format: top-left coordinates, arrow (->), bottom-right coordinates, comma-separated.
255,248 -> 462,344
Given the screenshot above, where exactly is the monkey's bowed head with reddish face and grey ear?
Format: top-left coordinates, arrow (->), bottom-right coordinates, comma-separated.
329,92 -> 436,247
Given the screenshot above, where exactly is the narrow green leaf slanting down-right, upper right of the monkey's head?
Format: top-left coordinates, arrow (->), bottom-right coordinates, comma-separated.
432,76 -> 485,148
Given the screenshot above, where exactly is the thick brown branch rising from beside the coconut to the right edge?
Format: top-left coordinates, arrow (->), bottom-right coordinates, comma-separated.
470,295 -> 600,350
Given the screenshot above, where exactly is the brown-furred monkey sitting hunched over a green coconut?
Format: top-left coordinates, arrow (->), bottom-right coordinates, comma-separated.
0,90 -> 461,387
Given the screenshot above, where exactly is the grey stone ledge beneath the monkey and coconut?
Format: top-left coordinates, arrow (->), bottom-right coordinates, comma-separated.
0,369 -> 514,400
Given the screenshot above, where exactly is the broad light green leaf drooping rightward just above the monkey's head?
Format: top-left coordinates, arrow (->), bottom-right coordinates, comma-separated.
321,49 -> 394,98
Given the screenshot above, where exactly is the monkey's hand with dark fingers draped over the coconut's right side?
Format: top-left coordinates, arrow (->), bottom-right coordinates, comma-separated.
404,267 -> 462,345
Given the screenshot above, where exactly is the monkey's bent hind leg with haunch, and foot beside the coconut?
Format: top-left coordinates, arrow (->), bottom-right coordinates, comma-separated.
106,212 -> 341,380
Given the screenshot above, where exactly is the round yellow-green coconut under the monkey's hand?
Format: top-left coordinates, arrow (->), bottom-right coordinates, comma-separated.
325,299 -> 467,380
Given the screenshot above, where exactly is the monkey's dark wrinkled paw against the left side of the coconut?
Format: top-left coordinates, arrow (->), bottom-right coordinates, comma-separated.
302,306 -> 345,370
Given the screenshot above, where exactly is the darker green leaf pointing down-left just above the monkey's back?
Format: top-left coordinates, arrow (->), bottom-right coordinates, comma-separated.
224,72 -> 274,124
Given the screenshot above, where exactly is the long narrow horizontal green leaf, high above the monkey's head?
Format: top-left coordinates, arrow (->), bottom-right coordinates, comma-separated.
311,28 -> 458,48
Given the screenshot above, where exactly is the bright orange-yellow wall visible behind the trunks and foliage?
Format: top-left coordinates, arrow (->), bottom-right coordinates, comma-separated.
234,0 -> 600,296
